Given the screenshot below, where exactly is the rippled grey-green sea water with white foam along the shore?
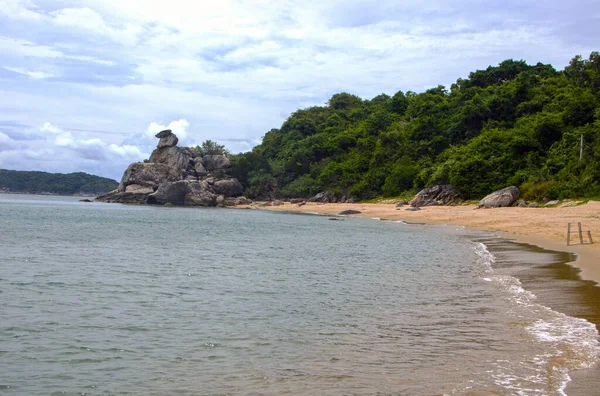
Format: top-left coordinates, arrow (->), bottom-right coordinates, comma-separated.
0,195 -> 598,395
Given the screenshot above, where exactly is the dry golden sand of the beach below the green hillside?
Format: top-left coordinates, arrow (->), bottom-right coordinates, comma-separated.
244,201 -> 600,283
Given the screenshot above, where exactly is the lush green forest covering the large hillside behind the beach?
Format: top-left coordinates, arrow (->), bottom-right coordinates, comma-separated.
232,52 -> 600,199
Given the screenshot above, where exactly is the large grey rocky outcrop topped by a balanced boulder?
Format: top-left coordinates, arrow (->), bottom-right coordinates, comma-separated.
96,129 -> 250,206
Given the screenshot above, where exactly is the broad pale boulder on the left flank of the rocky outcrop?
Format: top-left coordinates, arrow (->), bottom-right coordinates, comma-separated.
117,162 -> 181,192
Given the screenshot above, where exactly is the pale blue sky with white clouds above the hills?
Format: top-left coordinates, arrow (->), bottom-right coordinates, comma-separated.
0,0 -> 600,180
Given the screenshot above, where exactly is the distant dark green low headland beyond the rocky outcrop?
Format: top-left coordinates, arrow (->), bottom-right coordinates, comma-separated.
0,169 -> 118,195
